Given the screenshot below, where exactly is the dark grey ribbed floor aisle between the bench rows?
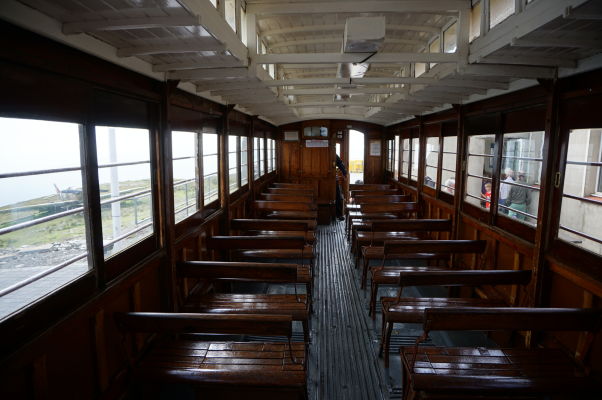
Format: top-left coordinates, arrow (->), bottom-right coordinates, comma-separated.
308,222 -> 388,400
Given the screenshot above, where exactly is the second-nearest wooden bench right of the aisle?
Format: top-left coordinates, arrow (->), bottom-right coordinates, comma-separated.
380,270 -> 531,367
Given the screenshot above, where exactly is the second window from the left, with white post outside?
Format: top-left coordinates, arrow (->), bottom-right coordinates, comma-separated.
96,126 -> 153,259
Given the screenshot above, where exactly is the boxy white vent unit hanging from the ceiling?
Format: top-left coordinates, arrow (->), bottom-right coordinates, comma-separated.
343,17 -> 385,53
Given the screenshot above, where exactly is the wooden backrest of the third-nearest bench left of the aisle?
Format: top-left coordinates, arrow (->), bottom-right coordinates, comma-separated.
207,236 -> 305,250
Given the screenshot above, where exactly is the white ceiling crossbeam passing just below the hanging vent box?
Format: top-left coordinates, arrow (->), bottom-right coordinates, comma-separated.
254,53 -> 458,64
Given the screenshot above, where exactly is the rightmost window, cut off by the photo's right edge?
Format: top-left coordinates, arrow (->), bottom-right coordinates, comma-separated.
558,129 -> 602,254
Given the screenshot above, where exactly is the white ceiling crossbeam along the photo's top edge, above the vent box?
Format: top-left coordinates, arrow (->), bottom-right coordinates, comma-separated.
247,0 -> 470,15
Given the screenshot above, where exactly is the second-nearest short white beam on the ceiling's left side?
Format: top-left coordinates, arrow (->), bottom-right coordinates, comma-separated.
117,36 -> 225,57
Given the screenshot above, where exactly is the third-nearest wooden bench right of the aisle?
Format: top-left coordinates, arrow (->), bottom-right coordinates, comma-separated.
362,240 -> 487,318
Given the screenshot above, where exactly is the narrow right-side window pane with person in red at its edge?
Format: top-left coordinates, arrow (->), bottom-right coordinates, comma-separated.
464,135 -> 495,209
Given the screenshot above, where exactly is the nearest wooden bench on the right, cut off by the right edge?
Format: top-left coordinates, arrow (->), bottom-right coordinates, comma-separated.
400,307 -> 602,400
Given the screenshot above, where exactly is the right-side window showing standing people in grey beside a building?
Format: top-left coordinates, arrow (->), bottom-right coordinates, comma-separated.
499,132 -> 544,225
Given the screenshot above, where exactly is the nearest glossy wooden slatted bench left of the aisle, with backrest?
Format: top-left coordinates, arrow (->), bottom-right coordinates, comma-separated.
115,313 -> 307,400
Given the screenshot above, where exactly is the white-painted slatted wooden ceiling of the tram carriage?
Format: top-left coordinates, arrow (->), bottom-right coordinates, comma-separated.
0,0 -> 602,125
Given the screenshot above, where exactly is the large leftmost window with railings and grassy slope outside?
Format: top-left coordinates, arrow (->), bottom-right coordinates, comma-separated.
0,118 -> 90,319
